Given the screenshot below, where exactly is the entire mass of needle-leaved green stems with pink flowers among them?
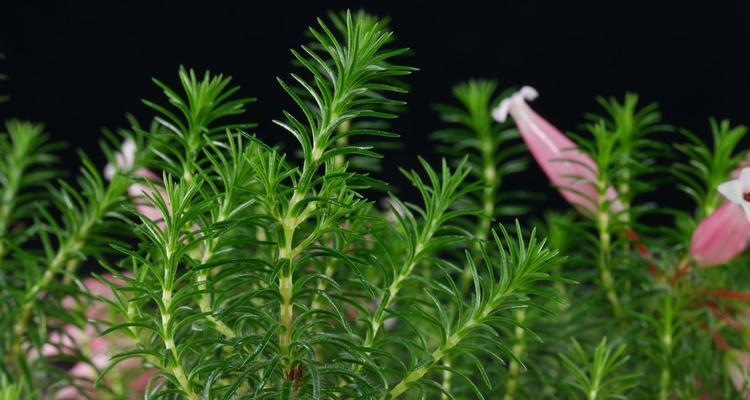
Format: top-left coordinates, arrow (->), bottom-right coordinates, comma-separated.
0,6 -> 750,400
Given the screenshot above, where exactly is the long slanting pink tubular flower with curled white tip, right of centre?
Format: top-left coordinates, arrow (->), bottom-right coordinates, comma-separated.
492,86 -> 622,213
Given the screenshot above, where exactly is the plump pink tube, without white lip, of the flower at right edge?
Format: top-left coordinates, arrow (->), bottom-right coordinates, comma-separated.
690,202 -> 750,267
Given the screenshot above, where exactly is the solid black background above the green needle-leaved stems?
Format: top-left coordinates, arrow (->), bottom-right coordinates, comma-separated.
0,1 -> 750,209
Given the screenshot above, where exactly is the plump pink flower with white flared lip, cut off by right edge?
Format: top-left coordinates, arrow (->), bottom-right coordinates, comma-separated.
690,168 -> 750,267
